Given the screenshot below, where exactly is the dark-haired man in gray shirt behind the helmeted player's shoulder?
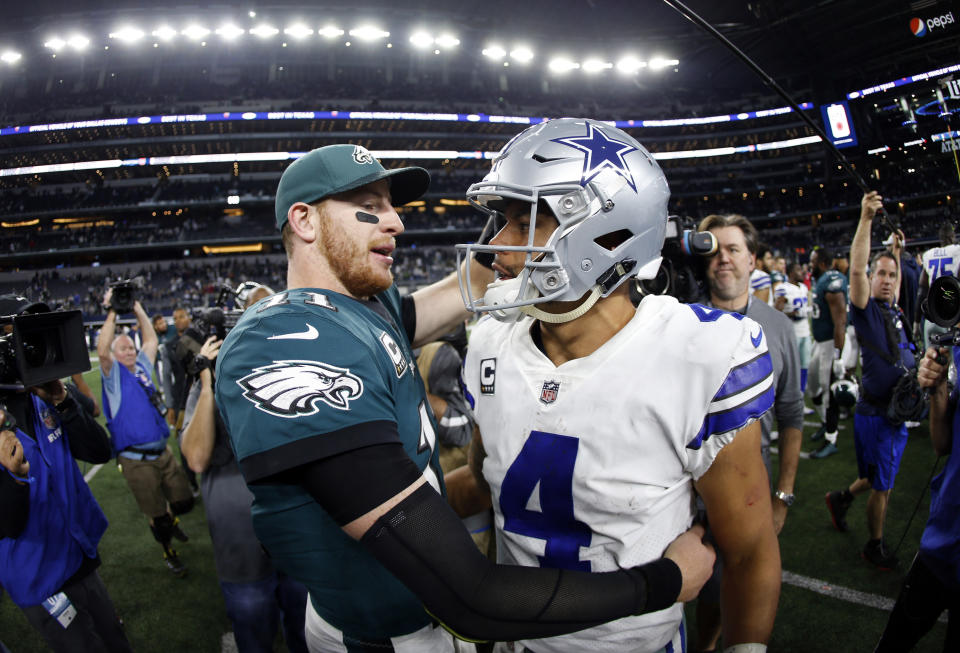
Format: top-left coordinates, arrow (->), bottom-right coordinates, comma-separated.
697,215 -> 803,651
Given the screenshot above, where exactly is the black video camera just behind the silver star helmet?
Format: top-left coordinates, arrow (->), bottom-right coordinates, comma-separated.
630,215 -> 717,304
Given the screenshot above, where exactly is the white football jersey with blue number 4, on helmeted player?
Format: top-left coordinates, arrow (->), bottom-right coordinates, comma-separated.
464,296 -> 774,653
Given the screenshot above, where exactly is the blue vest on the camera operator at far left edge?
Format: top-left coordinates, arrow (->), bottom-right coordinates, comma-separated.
0,397 -> 107,607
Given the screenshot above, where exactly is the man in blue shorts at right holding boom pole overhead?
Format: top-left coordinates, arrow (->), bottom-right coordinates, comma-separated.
826,191 -> 916,569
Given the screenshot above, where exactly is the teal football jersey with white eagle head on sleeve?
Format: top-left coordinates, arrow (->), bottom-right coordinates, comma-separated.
216,287 -> 444,638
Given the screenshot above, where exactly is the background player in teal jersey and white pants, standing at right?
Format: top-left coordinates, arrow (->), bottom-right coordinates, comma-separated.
807,247 -> 848,458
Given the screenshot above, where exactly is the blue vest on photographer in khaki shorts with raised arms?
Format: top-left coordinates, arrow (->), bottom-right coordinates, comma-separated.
100,356 -> 170,453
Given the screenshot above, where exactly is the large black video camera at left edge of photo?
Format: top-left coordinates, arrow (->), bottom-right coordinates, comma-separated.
0,297 -> 90,391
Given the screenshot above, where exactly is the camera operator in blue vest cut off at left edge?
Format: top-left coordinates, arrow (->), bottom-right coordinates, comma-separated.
0,295 -> 130,653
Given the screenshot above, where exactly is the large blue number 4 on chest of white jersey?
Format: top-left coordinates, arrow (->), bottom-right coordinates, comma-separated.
500,431 -> 591,571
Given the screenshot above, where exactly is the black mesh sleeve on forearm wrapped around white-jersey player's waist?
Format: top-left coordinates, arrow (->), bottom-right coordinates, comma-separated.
361,485 -> 682,641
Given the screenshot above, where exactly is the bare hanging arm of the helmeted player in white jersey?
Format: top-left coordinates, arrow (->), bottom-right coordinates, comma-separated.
696,422 -> 780,646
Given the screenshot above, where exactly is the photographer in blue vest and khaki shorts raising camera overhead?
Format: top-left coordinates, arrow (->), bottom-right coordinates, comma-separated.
97,289 -> 193,576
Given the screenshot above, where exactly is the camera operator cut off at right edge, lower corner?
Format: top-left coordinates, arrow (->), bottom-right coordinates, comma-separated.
875,347 -> 960,653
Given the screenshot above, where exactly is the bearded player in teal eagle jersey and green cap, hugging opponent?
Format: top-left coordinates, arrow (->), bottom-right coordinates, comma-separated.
216,145 -> 714,653
